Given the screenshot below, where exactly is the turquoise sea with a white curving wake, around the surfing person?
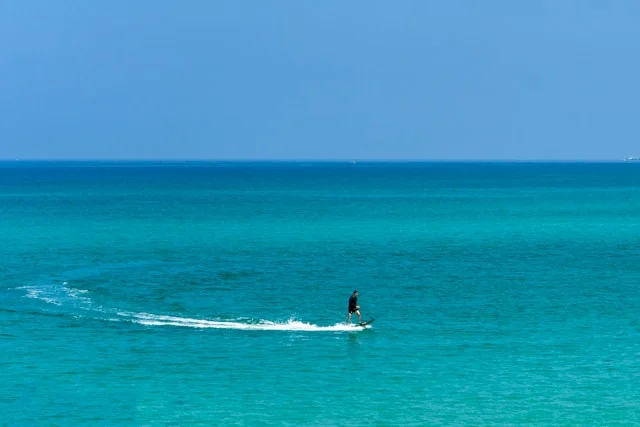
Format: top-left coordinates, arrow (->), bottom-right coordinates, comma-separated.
0,163 -> 640,426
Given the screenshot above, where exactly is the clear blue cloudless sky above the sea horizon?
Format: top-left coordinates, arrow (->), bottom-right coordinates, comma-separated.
0,0 -> 640,160
